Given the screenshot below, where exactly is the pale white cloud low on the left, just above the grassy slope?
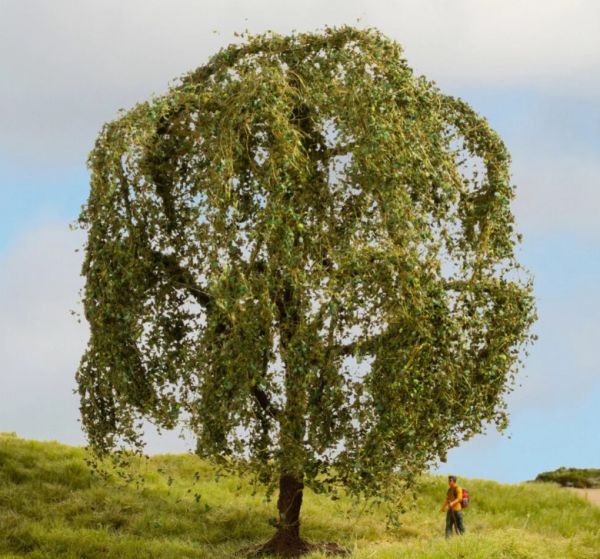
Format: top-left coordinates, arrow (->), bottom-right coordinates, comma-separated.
0,222 -> 191,453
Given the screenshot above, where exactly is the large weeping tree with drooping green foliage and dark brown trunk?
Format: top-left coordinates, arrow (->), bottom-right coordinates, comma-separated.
77,27 -> 535,555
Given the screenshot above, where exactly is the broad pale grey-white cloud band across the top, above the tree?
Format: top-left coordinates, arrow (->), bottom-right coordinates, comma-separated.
0,0 -> 600,162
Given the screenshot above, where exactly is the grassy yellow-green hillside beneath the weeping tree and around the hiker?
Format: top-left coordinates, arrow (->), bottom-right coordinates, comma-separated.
0,435 -> 600,559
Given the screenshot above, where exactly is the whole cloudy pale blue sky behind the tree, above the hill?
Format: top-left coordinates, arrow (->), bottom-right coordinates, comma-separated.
0,0 -> 600,482
